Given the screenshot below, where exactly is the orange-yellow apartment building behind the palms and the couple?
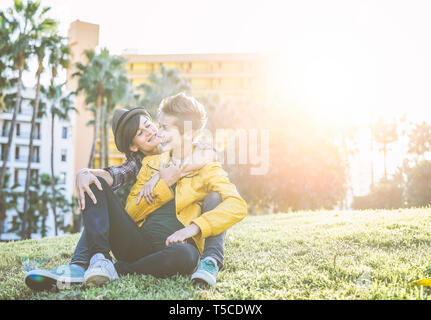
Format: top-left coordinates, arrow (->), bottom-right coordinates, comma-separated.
68,21 -> 269,173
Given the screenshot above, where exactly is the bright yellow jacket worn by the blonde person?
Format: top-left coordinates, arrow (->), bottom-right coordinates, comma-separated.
126,152 -> 247,253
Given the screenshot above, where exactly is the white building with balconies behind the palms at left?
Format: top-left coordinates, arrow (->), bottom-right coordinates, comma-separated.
0,90 -> 74,240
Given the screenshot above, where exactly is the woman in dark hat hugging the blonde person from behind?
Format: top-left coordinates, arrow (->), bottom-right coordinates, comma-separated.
25,94 -> 246,290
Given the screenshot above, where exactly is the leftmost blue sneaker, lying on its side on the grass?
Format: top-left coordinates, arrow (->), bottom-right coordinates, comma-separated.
24,264 -> 85,291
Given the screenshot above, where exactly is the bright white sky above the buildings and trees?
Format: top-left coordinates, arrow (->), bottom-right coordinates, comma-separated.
0,0 -> 431,195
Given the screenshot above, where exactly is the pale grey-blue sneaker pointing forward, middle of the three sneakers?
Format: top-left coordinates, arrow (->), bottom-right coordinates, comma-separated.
84,253 -> 118,287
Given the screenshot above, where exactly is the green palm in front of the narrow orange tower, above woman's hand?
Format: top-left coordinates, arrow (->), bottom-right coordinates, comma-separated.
73,48 -> 113,168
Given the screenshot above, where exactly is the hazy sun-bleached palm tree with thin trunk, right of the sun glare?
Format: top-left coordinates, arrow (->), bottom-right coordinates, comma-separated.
371,117 -> 398,180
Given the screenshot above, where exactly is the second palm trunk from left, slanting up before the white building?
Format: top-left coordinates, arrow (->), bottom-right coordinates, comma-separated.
22,59 -> 43,239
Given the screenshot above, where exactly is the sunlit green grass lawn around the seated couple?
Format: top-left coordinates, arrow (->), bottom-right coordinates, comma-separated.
0,209 -> 431,299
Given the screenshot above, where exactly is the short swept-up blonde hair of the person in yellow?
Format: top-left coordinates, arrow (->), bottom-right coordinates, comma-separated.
158,92 -> 207,134
